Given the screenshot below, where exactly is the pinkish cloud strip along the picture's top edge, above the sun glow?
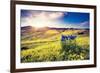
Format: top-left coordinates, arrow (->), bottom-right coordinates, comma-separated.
30,11 -> 64,20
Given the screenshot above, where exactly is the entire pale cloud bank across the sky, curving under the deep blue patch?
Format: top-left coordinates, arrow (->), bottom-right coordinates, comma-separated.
21,10 -> 89,28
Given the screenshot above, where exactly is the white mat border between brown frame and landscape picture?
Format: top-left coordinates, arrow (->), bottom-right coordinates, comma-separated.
15,4 -> 95,69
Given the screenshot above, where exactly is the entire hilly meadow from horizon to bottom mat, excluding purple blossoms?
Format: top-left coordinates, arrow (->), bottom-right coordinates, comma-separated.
21,27 -> 90,63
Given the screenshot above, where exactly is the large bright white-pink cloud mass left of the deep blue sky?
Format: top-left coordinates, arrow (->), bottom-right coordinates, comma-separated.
21,11 -> 64,27
